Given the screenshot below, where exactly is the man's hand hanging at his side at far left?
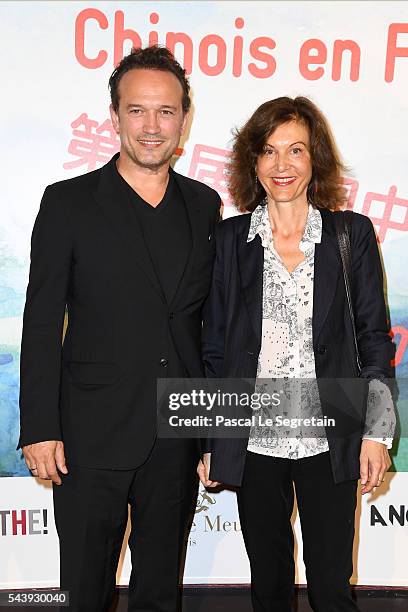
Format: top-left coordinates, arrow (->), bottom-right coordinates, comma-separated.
23,440 -> 68,485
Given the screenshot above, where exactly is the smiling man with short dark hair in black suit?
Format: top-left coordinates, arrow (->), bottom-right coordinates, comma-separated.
19,47 -> 220,612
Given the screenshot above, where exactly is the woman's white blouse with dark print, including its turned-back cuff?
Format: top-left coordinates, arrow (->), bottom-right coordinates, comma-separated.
247,205 -> 396,459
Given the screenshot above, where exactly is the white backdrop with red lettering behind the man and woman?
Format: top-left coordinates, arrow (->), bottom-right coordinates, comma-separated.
0,1 -> 408,588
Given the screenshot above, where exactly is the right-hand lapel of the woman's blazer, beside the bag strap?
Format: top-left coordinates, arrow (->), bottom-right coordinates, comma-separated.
313,210 -> 341,342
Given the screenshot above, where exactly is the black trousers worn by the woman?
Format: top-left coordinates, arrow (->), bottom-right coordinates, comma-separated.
238,452 -> 358,612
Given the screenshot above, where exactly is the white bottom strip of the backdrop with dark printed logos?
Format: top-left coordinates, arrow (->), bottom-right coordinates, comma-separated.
0,474 -> 408,589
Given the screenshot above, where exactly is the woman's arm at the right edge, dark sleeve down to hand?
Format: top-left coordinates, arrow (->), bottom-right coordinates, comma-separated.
351,215 -> 396,494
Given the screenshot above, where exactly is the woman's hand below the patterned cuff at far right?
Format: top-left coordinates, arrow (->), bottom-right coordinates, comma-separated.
360,440 -> 391,495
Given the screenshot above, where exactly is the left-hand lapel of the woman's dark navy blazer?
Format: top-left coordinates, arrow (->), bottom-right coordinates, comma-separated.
238,215 -> 264,346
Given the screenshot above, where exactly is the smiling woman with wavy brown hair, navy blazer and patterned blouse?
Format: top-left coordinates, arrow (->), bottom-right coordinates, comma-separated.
198,97 -> 395,612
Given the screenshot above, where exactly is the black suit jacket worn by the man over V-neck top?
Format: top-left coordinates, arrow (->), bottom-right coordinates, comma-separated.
19,155 -> 220,469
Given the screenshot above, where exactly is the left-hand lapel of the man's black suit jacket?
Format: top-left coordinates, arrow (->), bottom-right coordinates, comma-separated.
95,155 -> 165,301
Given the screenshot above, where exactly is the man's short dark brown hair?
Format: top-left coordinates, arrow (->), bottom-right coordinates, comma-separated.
109,45 -> 191,113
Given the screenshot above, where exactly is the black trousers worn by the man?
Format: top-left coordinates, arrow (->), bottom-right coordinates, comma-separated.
53,439 -> 199,612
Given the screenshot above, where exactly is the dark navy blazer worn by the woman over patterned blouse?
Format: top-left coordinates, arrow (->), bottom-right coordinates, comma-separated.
203,210 -> 394,485
